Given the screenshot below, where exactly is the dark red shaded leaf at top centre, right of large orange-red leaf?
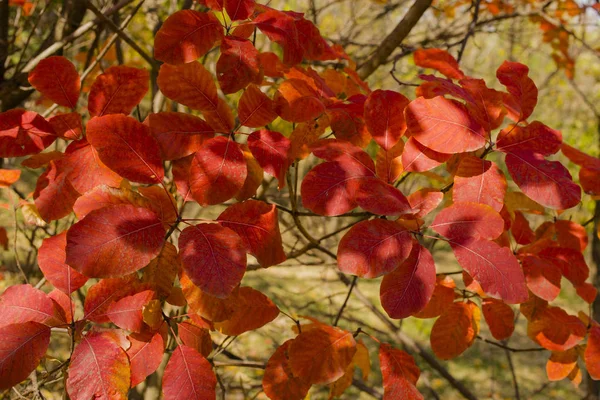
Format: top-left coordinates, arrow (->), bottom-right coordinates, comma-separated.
217,36 -> 263,94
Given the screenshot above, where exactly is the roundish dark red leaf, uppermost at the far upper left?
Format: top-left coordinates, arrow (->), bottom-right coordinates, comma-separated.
28,56 -> 81,109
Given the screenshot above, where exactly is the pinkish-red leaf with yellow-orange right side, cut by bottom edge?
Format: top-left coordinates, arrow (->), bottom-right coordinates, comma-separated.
66,333 -> 131,400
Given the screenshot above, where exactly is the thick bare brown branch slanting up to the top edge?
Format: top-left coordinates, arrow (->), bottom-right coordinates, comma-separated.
358,0 -> 432,79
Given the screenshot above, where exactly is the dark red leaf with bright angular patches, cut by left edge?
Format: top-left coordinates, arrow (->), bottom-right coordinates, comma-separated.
0,108 -> 56,158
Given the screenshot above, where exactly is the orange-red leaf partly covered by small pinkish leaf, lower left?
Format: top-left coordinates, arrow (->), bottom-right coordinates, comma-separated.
83,274 -> 144,323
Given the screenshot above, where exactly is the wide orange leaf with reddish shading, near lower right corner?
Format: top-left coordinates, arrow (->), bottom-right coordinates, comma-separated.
527,307 -> 586,351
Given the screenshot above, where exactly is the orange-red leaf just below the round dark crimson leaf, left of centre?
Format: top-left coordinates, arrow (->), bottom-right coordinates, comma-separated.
215,286 -> 279,336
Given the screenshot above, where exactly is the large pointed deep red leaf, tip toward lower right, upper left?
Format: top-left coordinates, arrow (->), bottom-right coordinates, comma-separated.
86,115 -> 165,183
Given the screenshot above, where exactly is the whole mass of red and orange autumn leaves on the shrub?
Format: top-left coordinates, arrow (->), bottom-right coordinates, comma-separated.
0,0 -> 600,400
